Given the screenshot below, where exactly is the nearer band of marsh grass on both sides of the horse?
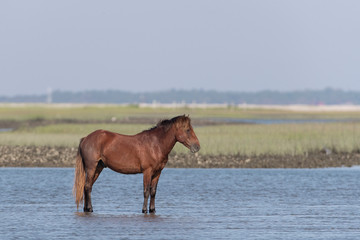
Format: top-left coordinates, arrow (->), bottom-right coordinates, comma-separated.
0,122 -> 360,155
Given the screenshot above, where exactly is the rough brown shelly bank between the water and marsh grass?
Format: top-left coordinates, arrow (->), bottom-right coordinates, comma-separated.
0,146 -> 360,168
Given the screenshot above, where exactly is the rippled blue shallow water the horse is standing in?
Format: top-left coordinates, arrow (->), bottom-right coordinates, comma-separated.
0,167 -> 360,239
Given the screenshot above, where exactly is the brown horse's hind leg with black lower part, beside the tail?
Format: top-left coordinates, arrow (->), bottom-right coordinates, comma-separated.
84,160 -> 104,212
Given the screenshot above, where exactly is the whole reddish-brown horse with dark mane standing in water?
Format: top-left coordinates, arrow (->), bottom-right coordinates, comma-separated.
73,115 -> 200,213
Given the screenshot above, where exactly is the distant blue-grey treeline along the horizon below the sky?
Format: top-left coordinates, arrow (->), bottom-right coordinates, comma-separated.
0,88 -> 360,105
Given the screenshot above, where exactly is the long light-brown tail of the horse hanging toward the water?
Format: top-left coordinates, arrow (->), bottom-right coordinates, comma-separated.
73,138 -> 85,208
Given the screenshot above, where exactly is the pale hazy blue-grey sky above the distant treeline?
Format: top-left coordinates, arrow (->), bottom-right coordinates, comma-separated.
0,0 -> 360,96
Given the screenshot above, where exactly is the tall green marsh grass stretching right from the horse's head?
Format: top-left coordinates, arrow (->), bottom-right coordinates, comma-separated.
175,123 -> 360,155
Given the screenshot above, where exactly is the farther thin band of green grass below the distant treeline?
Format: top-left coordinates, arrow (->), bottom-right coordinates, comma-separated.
0,104 -> 360,121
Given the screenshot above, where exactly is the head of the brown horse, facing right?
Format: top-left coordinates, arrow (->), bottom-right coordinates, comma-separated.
175,115 -> 200,153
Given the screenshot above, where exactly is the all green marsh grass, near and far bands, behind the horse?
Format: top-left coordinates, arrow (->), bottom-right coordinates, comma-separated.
0,105 -> 360,155
